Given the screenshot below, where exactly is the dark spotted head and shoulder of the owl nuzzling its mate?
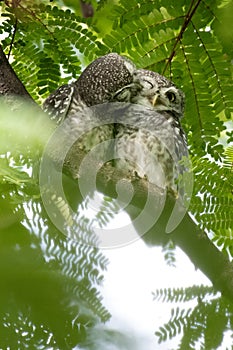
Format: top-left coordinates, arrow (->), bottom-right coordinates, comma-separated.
43,53 -> 136,124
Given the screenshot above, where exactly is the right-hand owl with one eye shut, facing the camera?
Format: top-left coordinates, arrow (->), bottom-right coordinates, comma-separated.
115,69 -> 188,193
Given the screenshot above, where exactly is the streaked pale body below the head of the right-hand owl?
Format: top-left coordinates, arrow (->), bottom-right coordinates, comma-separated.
115,105 -> 187,191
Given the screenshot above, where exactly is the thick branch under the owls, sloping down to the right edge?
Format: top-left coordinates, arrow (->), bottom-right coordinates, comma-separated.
65,149 -> 233,300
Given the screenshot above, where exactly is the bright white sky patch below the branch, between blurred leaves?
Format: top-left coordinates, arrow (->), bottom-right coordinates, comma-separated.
102,235 -> 211,350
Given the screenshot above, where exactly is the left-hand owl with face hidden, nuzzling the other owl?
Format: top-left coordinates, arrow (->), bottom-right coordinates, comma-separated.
43,53 -> 136,163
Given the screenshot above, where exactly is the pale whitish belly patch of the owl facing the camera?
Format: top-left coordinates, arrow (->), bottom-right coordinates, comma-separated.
116,127 -> 174,188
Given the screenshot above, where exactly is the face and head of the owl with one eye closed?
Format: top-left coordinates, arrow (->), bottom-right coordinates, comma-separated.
131,69 -> 184,118
